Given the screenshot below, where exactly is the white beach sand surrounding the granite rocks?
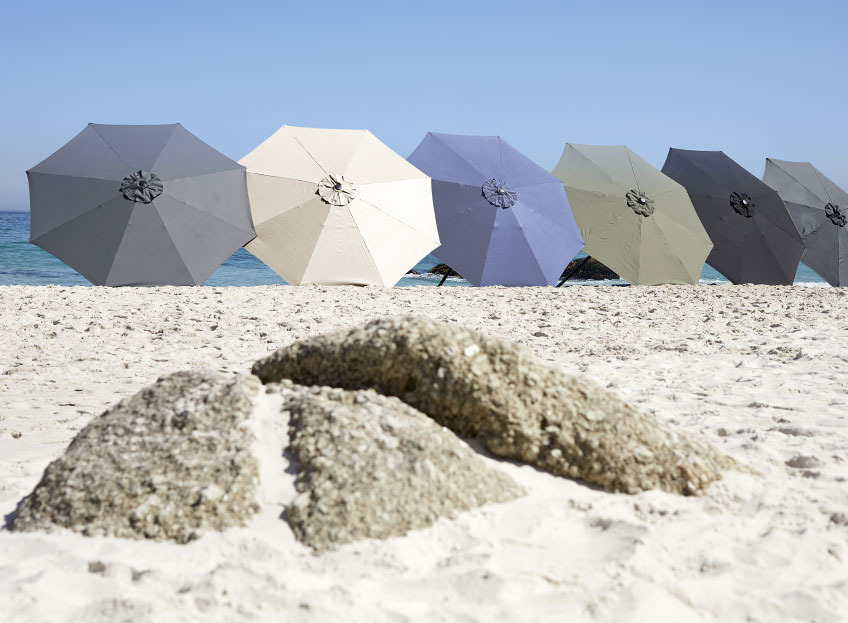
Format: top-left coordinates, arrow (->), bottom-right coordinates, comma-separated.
0,286 -> 848,623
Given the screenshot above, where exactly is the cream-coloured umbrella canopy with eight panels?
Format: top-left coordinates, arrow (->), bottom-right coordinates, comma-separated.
240,126 -> 439,286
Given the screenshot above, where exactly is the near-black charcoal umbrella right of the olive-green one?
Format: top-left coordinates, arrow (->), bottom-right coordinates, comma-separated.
663,149 -> 804,285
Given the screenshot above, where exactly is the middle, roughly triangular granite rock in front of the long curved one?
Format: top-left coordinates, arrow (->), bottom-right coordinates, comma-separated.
278,383 -> 524,550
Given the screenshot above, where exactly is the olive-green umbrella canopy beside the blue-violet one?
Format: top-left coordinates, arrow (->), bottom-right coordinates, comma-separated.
554,143 -> 713,285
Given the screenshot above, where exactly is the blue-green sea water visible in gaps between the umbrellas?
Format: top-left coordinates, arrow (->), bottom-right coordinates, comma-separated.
0,211 -> 825,286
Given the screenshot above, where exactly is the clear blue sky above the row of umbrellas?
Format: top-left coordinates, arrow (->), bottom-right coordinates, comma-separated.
0,0 -> 848,209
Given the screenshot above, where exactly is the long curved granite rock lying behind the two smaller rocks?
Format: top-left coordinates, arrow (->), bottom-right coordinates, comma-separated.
253,316 -> 735,494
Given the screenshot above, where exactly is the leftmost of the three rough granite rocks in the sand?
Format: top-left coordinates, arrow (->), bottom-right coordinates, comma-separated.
11,372 -> 259,543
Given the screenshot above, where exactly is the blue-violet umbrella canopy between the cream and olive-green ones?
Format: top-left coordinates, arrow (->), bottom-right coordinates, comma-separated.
409,132 -> 583,286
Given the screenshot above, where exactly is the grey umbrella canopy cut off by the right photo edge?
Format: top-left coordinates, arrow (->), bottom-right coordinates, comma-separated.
763,158 -> 848,286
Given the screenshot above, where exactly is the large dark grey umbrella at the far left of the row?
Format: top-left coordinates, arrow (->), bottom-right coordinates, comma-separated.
27,123 -> 254,286
